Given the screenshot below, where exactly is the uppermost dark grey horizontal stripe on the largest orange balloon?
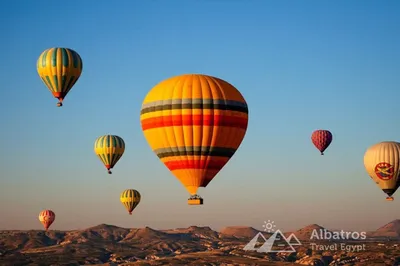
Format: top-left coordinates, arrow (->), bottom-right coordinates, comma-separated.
140,99 -> 248,115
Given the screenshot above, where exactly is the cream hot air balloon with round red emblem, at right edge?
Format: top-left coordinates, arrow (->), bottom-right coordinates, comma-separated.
364,141 -> 400,201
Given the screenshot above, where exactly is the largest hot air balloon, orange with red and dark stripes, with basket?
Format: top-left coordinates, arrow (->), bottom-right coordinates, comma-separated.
140,74 -> 248,205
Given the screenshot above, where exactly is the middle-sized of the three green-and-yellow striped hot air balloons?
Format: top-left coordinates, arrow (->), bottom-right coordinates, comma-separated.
94,135 -> 125,174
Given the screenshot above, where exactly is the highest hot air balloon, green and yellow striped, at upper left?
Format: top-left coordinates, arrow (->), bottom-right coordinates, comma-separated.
37,47 -> 83,107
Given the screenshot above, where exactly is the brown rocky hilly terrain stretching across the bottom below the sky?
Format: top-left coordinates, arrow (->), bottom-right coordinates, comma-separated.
0,220 -> 400,266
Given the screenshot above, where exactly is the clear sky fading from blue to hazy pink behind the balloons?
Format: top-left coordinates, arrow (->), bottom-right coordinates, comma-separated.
0,0 -> 400,233
